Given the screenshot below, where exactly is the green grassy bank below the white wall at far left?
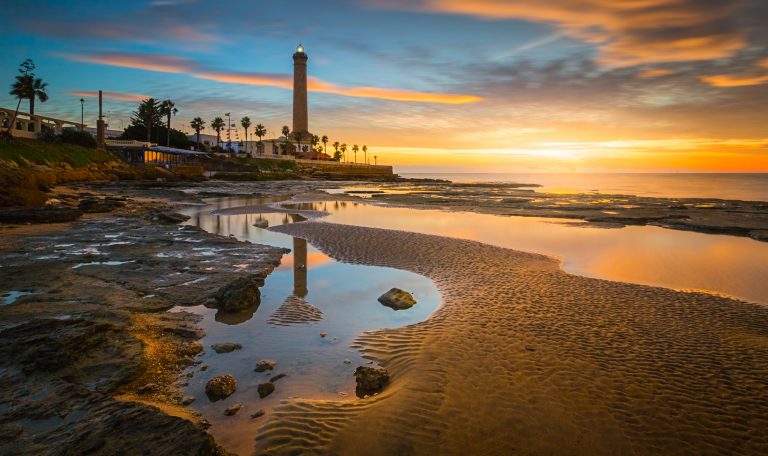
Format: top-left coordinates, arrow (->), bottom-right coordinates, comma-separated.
0,138 -> 116,168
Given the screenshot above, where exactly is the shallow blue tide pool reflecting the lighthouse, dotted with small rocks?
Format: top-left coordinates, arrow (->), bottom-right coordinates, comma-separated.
175,198 -> 440,454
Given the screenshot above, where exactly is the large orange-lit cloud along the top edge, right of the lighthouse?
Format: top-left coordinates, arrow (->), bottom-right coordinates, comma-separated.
376,0 -> 746,67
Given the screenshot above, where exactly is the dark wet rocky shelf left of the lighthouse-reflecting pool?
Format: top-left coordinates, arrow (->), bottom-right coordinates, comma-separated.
0,189 -> 285,455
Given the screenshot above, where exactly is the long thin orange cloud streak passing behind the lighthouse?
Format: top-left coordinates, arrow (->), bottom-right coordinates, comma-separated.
67,52 -> 483,104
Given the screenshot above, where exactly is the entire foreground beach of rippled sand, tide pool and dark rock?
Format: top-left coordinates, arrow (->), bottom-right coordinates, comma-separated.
0,181 -> 768,455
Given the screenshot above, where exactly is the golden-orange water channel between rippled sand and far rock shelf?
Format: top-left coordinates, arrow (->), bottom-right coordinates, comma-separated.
312,204 -> 768,303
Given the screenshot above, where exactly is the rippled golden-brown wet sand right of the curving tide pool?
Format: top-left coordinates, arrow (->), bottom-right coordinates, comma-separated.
257,221 -> 768,455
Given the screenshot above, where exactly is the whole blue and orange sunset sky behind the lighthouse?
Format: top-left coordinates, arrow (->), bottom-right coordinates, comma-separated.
0,0 -> 768,172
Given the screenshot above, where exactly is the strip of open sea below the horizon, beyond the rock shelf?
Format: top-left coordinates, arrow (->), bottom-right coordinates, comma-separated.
399,173 -> 768,201
